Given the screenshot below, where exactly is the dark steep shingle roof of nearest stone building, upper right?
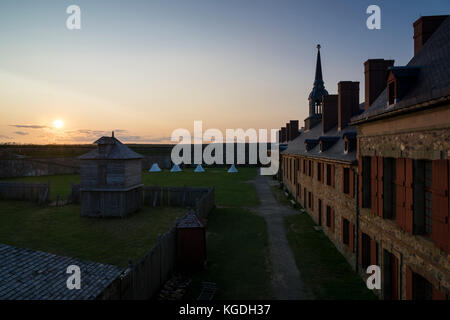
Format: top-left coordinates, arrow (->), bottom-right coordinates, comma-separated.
352,16 -> 450,123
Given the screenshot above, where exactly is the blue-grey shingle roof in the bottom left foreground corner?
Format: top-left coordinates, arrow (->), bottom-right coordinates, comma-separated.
0,244 -> 123,300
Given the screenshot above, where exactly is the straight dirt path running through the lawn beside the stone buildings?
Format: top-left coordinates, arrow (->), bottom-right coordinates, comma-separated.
254,175 -> 313,300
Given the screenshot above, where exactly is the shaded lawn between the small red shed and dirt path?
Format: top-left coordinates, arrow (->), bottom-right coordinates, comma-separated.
185,208 -> 271,300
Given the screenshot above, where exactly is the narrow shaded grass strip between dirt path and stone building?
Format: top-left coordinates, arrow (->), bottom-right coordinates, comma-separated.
285,214 -> 376,300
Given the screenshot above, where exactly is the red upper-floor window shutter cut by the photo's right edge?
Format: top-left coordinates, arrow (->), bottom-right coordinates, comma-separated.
432,160 -> 450,253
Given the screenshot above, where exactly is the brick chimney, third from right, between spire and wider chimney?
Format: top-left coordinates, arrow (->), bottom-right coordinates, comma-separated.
338,81 -> 359,131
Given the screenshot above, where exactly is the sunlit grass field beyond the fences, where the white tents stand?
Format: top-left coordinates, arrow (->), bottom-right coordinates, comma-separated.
3,167 -> 258,207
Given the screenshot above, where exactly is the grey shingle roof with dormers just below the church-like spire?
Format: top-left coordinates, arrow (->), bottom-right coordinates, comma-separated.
281,122 -> 356,163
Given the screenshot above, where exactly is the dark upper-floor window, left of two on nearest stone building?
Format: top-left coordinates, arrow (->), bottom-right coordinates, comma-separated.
383,158 -> 397,219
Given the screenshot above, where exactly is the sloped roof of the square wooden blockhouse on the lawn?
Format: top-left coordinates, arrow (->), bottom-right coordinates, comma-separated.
78,137 -> 143,160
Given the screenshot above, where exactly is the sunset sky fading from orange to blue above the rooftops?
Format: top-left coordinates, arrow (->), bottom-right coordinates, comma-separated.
0,0 -> 450,144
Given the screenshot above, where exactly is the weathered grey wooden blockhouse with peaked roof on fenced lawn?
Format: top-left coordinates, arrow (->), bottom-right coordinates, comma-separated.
78,132 -> 143,217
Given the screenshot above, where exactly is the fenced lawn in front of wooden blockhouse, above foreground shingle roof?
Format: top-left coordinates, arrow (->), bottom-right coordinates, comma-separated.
0,201 -> 184,267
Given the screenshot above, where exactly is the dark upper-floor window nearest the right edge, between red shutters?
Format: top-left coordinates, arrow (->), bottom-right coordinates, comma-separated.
413,160 -> 433,236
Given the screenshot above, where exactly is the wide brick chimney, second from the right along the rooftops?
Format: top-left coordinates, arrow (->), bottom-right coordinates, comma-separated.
364,59 -> 394,110
